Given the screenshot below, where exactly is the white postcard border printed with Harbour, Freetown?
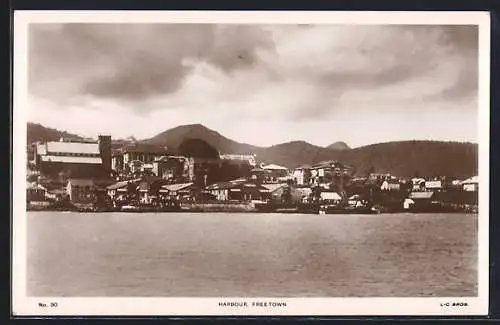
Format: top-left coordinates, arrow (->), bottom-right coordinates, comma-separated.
12,11 -> 490,316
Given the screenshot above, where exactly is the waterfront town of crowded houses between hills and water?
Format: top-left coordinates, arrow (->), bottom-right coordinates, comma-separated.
26,135 -> 478,214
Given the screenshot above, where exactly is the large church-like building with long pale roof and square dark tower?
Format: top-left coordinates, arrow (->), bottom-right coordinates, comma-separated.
33,135 -> 111,178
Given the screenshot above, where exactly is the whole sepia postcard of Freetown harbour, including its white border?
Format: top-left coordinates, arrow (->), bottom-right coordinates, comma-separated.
12,12 -> 490,315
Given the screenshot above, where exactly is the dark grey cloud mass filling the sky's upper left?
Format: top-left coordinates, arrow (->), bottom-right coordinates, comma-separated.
29,23 -> 272,99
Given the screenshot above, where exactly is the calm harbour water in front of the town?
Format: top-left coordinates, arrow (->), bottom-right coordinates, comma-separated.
27,212 -> 478,297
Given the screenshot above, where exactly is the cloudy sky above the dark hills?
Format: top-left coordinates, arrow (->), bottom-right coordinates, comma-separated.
28,23 -> 478,147
